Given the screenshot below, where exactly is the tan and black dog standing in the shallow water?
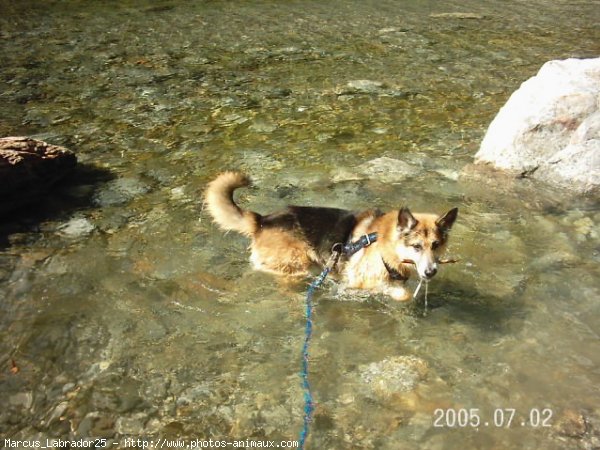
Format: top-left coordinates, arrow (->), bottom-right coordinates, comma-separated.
204,172 -> 458,301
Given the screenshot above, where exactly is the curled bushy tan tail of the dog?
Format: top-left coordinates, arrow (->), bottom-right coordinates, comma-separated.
204,172 -> 260,236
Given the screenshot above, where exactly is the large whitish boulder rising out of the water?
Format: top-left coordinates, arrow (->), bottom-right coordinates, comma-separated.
475,58 -> 600,192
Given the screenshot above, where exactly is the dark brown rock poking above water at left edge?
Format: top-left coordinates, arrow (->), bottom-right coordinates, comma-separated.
0,137 -> 77,214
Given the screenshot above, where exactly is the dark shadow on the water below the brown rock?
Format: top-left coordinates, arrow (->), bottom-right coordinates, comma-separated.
0,163 -> 115,249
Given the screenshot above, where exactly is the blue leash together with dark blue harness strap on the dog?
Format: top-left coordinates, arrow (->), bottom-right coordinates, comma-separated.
298,233 -> 377,450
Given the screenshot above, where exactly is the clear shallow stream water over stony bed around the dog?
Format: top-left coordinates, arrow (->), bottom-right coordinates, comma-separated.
0,0 -> 600,449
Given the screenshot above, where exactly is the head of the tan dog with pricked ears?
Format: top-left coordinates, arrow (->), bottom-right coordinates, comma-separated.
396,208 -> 458,280
